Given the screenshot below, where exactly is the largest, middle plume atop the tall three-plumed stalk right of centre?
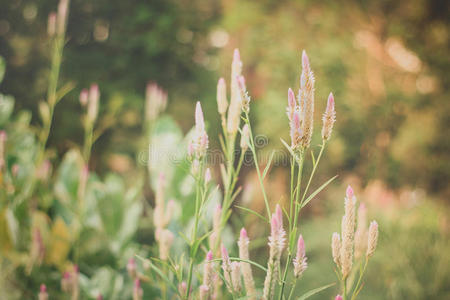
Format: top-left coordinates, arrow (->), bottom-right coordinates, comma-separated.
300,50 -> 314,148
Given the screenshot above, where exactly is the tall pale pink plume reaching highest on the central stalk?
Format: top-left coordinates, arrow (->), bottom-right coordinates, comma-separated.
227,49 -> 242,136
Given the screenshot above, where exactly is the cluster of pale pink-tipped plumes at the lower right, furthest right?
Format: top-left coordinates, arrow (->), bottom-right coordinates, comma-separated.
331,186 -> 378,300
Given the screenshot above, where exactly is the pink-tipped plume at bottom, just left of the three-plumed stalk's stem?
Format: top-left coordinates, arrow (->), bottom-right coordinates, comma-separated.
263,205 -> 286,299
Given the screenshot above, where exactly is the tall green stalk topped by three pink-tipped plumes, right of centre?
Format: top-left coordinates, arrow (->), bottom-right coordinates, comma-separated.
279,51 -> 336,300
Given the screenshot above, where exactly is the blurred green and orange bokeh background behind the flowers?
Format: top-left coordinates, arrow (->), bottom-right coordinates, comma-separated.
0,0 -> 450,299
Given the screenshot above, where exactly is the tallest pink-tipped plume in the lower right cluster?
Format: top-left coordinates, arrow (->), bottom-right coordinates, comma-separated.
341,186 -> 356,279
